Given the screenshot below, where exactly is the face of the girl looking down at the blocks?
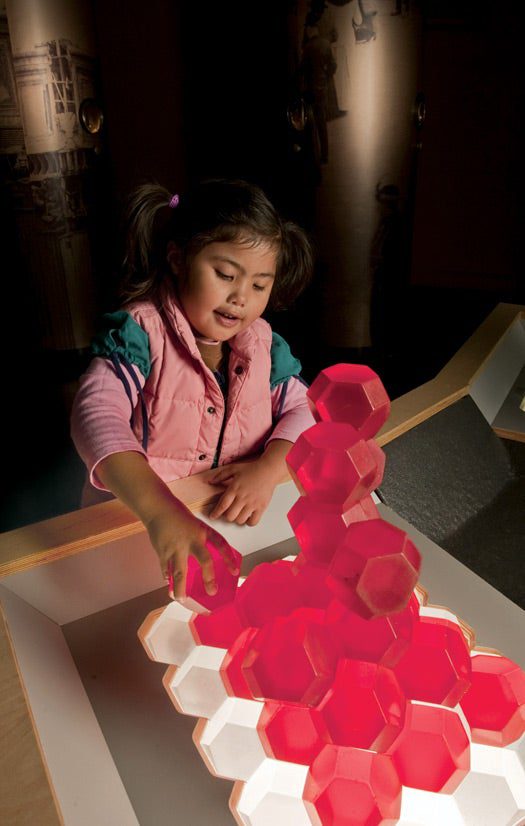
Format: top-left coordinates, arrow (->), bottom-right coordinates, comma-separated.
173,241 -> 277,341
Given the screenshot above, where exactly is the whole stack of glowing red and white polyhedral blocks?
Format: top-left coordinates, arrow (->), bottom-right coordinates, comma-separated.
139,364 -> 525,826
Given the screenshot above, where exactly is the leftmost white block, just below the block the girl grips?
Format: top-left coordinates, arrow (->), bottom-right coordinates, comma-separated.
137,602 -> 196,665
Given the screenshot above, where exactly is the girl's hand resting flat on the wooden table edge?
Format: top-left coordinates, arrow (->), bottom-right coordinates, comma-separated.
209,439 -> 290,525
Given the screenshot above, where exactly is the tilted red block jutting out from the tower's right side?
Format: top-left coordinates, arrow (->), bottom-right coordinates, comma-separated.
327,519 -> 421,618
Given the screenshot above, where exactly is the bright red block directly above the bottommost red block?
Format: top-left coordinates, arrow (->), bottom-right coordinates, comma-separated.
319,660 -> 406,751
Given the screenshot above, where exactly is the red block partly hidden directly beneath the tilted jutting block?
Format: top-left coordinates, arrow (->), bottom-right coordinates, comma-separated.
325,598 -> 417,668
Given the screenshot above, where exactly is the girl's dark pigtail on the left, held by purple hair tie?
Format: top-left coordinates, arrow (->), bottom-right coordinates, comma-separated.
121,183 -> 173,302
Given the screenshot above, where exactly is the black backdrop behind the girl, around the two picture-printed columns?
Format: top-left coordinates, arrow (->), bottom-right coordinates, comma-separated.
0,0 -> 525,530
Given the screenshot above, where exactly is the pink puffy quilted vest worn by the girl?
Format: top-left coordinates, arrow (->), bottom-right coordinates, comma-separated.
126,296 -> 272,479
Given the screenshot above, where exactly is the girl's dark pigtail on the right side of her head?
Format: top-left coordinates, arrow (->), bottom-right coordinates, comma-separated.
270,221 -> 314,310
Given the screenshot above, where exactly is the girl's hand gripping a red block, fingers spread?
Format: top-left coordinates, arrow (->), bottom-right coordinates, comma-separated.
145,499 -> 239,599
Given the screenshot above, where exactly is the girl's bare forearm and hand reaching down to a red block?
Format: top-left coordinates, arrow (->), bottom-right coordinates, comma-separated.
97,451 -> 238,598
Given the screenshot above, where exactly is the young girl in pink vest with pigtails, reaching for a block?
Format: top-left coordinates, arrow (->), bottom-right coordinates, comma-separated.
72,180 -> 314,597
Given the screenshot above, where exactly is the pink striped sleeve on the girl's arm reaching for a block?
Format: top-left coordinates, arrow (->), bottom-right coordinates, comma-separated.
71,358 -> 146,490
